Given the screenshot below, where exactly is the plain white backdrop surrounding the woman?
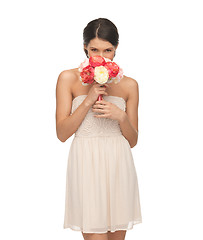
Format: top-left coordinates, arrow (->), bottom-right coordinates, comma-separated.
0,0 -> 203,240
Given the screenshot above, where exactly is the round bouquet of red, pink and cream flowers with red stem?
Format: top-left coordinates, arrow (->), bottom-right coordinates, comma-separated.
78,56 -> 123,101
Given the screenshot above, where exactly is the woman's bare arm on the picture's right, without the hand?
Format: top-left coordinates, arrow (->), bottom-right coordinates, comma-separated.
119,79 -> 139,148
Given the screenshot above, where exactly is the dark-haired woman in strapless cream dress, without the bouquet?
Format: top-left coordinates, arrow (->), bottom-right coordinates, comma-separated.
56,18 -> 142,240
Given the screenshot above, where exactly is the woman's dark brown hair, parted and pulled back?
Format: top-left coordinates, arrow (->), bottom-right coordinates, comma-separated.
83,18 -> 119,57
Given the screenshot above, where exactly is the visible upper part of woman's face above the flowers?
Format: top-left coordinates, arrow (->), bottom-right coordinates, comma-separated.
84,38 -> 117,61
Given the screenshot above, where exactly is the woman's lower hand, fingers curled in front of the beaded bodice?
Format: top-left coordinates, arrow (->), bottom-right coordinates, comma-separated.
92,99 -> 123,121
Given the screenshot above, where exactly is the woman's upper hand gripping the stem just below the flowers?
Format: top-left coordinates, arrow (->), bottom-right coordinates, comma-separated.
85,82 -> 109,105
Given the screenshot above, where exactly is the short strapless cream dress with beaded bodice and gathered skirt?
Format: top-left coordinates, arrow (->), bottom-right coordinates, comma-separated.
63,95 -> 142,233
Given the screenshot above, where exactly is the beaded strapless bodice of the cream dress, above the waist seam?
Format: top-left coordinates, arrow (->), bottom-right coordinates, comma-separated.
71,95 -> 126,137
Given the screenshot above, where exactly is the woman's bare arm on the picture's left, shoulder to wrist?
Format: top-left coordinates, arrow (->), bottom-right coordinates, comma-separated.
56,70 -> 92,142
